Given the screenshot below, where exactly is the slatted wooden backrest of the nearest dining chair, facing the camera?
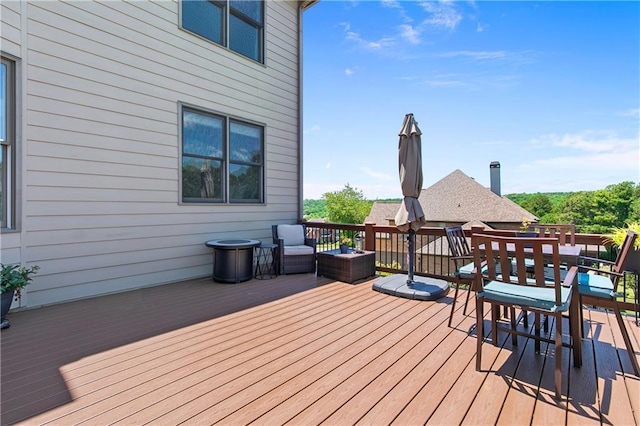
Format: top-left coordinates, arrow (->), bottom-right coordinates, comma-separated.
471,234 -> 562,304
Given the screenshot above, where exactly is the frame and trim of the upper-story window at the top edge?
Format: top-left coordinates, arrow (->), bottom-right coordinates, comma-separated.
179,0 -> 267,65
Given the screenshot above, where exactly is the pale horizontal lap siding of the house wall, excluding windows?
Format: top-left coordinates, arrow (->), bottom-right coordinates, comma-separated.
2,1 -> 300,306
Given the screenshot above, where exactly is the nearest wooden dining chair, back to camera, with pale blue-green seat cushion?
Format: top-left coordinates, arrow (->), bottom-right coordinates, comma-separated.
471,234 -> 582,399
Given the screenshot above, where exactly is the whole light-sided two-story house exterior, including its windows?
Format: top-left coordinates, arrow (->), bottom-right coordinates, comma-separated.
0,0 -> 314,308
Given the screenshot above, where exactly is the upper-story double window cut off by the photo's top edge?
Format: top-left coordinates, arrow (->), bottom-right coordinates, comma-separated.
181,0 -> 264,62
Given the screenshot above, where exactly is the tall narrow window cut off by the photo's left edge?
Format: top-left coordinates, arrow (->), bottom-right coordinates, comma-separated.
0,56 -> 16,228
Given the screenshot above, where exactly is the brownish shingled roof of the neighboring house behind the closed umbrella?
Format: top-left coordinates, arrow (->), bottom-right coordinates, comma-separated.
366,170 -> 538,227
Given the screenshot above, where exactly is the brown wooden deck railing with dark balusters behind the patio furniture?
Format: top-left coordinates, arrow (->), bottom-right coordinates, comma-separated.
305,222 -> 640,318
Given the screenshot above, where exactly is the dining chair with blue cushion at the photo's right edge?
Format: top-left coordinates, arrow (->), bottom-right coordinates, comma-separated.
578,231 -> 640,376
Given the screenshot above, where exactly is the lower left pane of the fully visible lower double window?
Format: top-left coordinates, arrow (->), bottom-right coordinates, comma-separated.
182,157 -> 222,202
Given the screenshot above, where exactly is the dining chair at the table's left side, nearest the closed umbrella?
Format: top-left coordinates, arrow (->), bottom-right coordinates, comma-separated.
444,226 -> 475,327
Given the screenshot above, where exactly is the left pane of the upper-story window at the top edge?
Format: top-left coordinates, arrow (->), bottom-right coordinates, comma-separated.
181,0 -> 224,44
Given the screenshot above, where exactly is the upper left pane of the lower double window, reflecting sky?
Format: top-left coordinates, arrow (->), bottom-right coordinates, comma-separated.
182,110 -> 224,158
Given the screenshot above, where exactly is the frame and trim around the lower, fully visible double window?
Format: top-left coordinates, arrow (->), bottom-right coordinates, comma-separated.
178,103 -> 267,206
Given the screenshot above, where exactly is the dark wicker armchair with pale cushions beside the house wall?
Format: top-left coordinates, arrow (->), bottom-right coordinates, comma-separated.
271,225 -> 316,275
